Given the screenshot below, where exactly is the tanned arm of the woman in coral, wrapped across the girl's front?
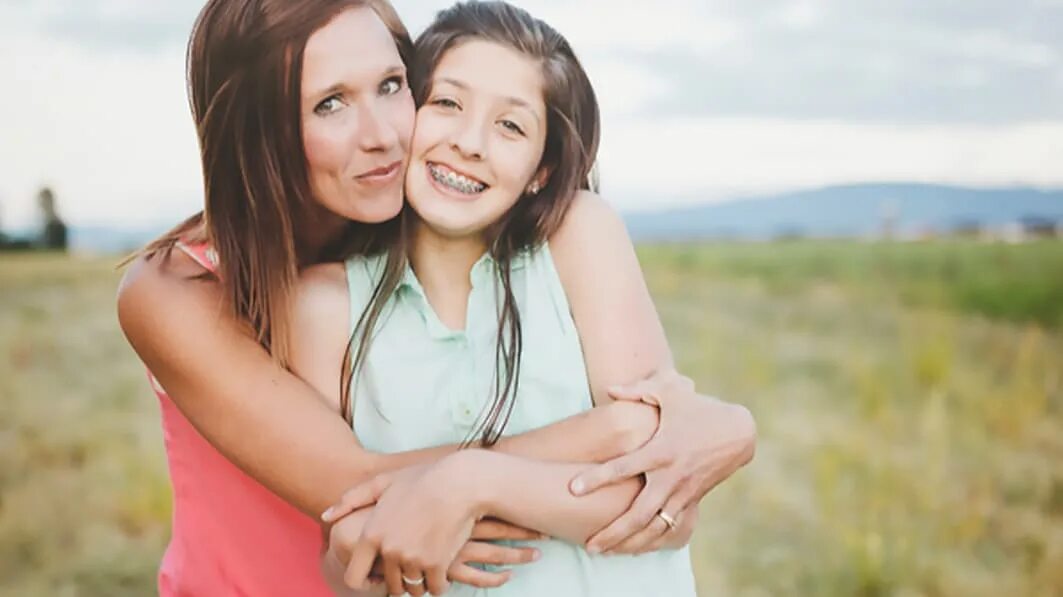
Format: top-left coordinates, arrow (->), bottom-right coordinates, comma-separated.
118,252 -> 656,516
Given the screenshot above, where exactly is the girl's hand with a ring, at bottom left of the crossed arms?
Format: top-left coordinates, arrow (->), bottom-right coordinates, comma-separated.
322,453 -> 512,597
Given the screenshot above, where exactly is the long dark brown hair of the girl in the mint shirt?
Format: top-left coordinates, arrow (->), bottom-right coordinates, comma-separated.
341,1 -> 601,445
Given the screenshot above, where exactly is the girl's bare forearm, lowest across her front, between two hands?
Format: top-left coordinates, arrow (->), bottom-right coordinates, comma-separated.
453,450 -> 642,544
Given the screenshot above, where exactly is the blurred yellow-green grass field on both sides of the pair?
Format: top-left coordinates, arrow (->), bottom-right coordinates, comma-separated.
0,242 -> 1063,596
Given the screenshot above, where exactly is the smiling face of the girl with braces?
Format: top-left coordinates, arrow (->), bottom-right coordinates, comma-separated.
406,40 -> 546,237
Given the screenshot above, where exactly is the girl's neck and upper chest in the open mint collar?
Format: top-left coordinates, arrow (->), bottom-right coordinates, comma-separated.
409,220 -> 487,329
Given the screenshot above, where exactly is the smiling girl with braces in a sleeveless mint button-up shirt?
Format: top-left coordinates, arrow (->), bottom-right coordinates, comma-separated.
292,2 -> 752,596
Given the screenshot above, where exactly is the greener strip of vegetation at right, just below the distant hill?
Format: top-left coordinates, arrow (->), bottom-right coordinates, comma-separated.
643,241 -> 1063,328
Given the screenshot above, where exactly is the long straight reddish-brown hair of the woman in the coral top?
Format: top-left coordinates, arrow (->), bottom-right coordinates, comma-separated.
135,0 -> 412,365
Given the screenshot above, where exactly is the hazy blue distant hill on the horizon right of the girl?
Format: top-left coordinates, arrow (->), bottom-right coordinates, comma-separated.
625,184 -> 1063,240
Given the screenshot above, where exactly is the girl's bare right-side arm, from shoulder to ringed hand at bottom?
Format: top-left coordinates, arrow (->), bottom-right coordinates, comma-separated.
327,193 -> 752,589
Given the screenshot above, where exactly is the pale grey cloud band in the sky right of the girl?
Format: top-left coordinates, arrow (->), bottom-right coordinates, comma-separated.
614,0 -> 1063,123
